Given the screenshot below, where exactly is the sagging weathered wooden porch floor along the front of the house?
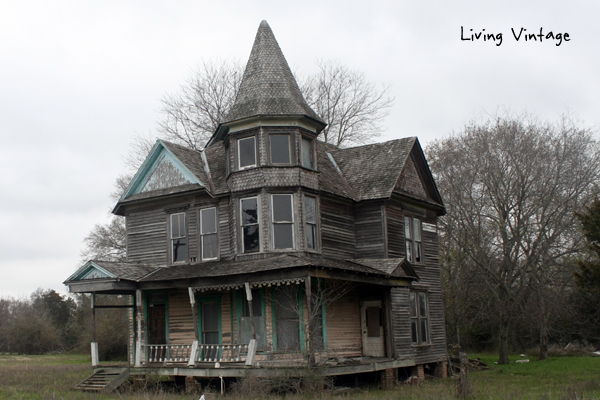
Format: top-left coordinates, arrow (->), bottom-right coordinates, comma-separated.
94,357 -> 415,378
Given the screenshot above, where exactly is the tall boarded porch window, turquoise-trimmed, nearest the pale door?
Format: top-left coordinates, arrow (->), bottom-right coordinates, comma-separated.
275,285 -> 300,350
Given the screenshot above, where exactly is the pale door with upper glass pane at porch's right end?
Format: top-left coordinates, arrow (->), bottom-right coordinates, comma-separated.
360,300 -> 385,357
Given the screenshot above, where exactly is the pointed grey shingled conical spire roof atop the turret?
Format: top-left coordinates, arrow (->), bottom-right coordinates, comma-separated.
225,21 -> 325,125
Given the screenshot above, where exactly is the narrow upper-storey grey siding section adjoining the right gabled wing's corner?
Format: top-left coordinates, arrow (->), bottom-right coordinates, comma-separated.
354,202 -> 385,258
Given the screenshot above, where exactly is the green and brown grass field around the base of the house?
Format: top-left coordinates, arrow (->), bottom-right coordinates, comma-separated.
0,354 -> 600,400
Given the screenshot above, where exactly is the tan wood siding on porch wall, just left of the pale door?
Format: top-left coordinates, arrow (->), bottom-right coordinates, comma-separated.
326,290 -> 362,357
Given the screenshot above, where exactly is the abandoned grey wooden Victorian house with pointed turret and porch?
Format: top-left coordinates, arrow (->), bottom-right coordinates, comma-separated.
65,21 -> 447,390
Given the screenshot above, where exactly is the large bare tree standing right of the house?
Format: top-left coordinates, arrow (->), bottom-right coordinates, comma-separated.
428,115 -> 600,363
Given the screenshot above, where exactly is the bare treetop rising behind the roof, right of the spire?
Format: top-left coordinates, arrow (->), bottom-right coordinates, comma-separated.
301,61 -> 394,146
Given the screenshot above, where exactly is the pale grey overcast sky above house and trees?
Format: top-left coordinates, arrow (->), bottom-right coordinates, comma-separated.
0,0 -> 600,297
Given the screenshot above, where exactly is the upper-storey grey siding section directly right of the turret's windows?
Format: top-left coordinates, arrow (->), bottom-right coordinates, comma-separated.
320,195 -> 356,259
